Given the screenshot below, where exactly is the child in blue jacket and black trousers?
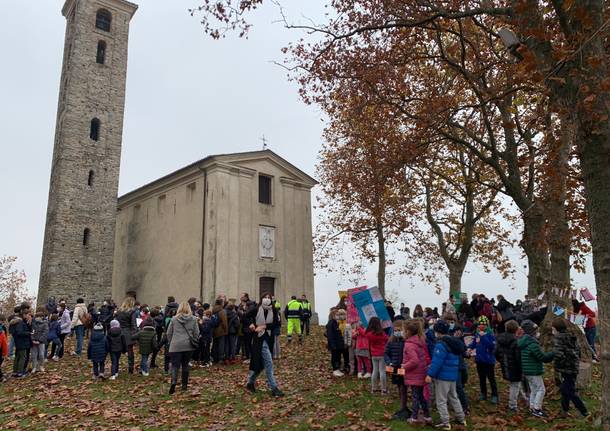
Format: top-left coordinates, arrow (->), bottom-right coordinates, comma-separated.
468,316 -> 498,404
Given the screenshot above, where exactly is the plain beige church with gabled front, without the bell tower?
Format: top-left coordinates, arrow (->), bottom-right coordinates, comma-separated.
112,150 -> 316,304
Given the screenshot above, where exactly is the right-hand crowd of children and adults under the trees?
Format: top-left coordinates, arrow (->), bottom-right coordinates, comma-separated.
326,294 -> 596,430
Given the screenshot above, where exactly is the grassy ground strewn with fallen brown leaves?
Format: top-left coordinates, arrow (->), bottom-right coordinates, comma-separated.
0,328 -> 601,431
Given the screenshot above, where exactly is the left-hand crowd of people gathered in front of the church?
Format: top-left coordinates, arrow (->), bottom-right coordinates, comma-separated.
0,293 -> 311,396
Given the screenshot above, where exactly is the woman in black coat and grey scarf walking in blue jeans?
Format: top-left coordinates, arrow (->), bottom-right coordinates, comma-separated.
246,293 -> 284,397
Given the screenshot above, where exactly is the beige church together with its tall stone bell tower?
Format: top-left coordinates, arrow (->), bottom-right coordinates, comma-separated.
38,0 -> 316,314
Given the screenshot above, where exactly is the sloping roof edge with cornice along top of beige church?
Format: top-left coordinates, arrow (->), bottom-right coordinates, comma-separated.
119,150 -> 318,206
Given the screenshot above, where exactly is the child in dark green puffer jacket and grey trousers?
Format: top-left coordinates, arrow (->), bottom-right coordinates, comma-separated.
517,320 -> 555,417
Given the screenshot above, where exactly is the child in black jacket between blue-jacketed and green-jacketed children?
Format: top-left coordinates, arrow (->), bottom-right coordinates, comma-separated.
496,320 -> 523,413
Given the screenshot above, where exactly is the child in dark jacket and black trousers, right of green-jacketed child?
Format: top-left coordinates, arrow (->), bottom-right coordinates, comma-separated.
553,317 -> 589,418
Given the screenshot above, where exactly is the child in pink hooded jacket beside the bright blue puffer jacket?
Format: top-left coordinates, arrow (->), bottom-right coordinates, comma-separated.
402,320 -> 432,424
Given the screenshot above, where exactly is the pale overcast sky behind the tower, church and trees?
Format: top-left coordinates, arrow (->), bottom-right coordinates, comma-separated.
0,0 -> 593,320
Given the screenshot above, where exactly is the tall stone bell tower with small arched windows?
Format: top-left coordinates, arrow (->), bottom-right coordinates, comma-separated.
38,0 -> 137,304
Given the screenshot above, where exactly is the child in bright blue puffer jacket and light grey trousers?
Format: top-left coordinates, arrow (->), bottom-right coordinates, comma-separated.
426,320 -> 466,430
